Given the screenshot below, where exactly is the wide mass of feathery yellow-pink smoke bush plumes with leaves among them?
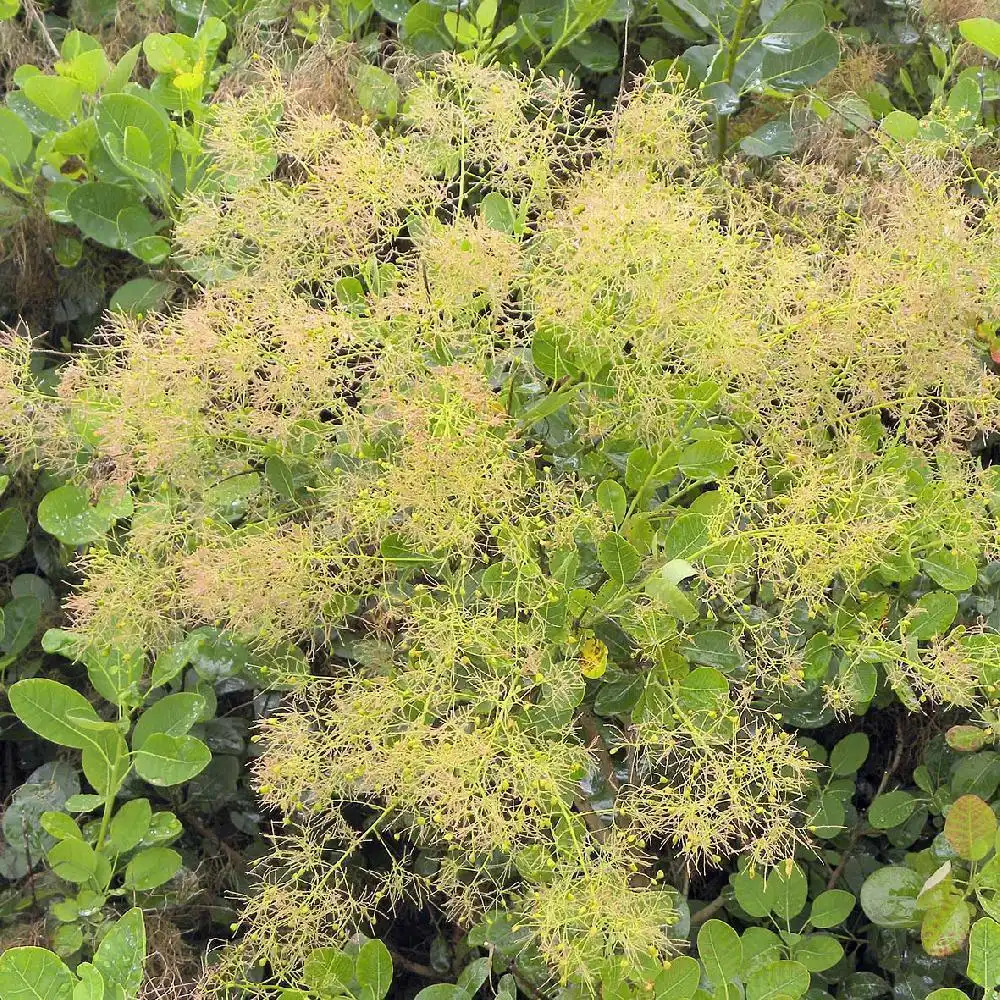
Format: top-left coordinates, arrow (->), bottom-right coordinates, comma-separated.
0,60 -> 1000,992
